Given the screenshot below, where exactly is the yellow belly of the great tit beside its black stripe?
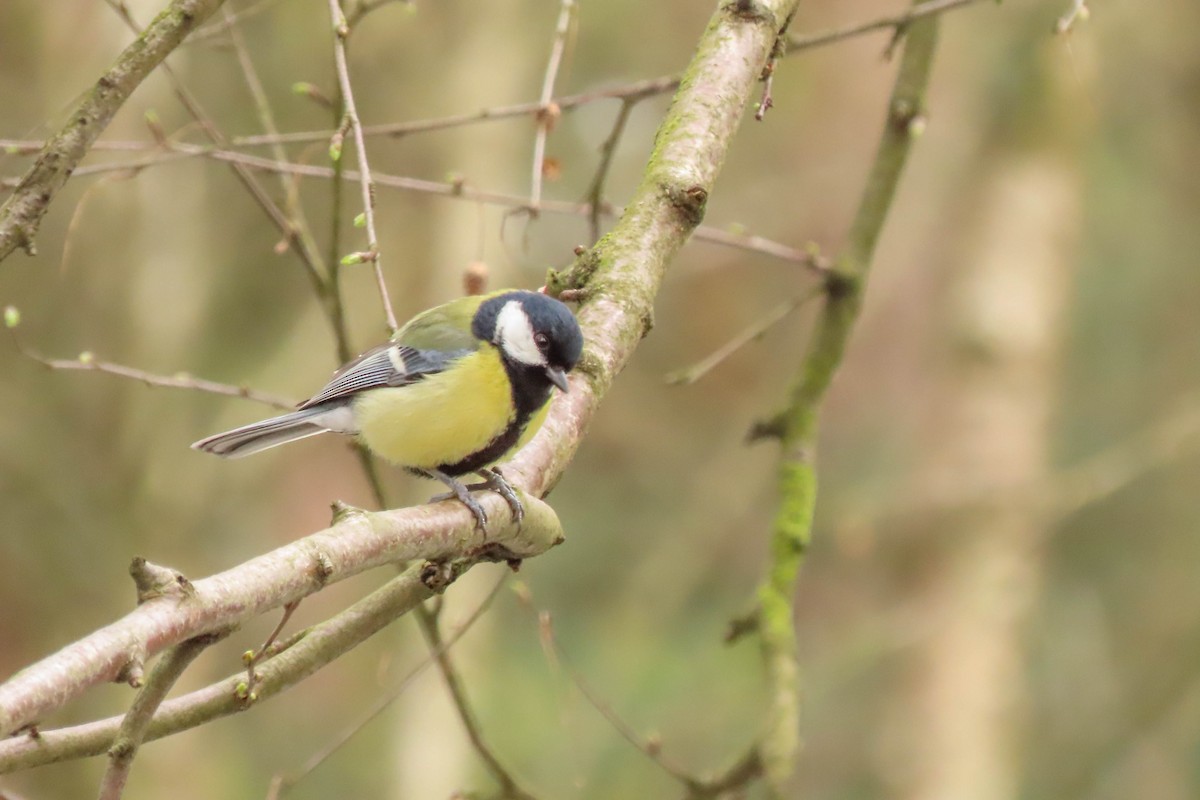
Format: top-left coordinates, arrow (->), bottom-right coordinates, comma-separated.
354,345 -> 525,469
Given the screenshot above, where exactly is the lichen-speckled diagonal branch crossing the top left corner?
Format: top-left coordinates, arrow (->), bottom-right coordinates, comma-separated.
0,0 -> 223,261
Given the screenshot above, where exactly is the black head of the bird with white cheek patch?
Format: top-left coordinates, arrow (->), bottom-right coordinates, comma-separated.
472,291 -> 583,392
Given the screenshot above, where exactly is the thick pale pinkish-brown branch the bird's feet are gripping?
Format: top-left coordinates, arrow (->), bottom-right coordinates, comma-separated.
0,495 -> 562,735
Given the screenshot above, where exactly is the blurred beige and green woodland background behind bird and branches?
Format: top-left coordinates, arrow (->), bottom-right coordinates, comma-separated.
0,0 -> 1200,800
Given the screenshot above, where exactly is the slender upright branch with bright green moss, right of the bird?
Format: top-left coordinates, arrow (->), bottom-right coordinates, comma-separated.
757,18 -> 937,794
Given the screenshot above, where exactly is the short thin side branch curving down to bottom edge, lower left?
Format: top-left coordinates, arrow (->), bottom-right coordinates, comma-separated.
100,636 -> 220,800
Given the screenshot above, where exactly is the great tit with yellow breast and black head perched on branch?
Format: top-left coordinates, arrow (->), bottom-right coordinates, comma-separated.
192,290 -> 583,528
